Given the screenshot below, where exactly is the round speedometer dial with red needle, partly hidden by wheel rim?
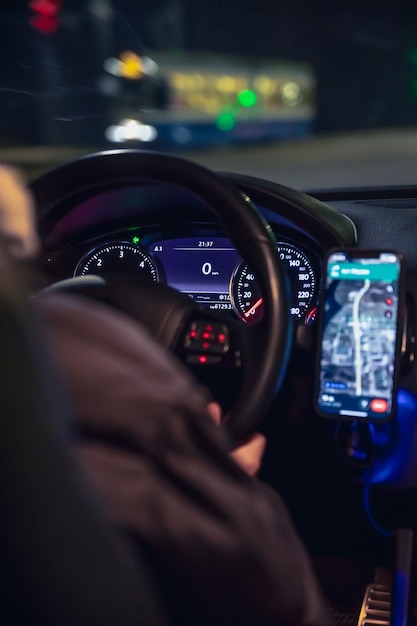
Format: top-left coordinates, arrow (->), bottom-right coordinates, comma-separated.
231,242 -> 316,324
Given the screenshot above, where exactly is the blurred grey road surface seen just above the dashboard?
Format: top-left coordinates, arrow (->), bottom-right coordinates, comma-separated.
0,129 -> 417,190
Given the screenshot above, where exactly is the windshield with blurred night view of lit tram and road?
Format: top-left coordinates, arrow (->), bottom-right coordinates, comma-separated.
0,0 -> 417,189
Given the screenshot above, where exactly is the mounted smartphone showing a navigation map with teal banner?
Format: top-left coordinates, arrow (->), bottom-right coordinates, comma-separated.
315,249 -> 404,421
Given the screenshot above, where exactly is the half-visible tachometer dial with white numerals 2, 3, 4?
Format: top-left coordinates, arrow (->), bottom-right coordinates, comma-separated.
74,241 -> 158,282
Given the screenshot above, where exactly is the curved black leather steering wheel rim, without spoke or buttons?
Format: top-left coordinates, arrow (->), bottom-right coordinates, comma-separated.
32,150 -> 291,441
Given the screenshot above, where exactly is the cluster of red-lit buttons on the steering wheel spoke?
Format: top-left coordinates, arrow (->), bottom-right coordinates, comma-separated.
184,321 -> 230,356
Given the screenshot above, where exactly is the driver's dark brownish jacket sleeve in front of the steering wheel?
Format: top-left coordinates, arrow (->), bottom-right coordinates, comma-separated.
42,297 -> 325,626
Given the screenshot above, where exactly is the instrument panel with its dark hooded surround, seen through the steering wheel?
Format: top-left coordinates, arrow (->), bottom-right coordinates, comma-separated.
41,173 -> 328,327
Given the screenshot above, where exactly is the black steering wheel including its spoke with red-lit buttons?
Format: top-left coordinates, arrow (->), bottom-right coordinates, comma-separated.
33,150 -> 291,443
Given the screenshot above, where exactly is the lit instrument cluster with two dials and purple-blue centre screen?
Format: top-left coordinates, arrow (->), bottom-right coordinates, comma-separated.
74,236 -> 319,325
